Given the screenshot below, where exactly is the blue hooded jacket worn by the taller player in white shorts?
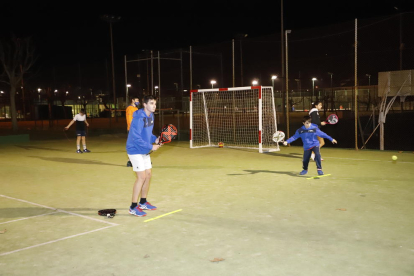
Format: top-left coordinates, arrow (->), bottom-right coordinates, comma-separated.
126,108 -> 157,154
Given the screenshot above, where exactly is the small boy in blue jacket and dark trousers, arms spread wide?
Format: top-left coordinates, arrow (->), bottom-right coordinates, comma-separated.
283,116 -> 337,175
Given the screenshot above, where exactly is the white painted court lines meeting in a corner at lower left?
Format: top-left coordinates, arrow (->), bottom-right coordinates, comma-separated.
0,195 -> 119,256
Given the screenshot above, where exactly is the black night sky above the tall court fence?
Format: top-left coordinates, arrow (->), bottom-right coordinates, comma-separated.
0,0 -> 414,90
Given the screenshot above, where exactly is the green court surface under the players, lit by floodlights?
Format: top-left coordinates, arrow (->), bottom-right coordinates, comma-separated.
0,138 -> 414,276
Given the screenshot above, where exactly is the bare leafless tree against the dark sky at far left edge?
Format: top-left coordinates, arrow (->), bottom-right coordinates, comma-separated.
0,35 -> 37,131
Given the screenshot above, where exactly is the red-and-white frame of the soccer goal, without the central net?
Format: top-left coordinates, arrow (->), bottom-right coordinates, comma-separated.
190,86 -> 280,153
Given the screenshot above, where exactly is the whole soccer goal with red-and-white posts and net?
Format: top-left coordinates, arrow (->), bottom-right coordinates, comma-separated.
190,86 -> 279,153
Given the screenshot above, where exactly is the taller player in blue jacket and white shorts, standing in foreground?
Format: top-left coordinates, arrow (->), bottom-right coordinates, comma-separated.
126,95 -> 161,217
